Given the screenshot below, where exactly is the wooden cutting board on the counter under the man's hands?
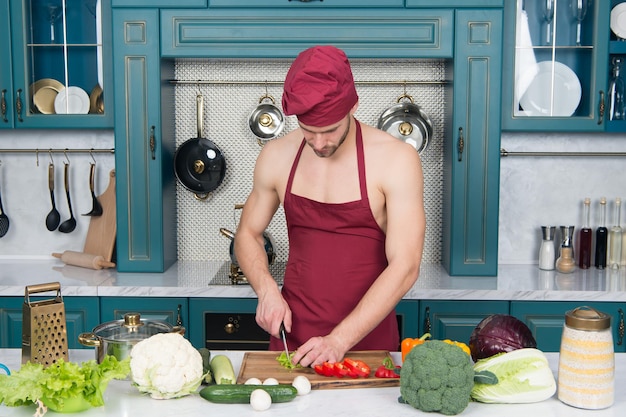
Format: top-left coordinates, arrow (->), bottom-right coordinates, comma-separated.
237,350 -> 400,389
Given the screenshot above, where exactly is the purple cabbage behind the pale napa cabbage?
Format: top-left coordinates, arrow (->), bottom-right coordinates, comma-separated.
469,314 -> 537,362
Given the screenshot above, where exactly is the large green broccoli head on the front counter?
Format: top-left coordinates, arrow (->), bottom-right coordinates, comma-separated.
398,340 -> 474,415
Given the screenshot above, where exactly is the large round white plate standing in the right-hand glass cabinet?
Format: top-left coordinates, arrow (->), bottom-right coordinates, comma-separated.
520,61 -> 582,117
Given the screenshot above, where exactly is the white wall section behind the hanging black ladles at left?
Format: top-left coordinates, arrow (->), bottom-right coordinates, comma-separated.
0,130 -> 114,259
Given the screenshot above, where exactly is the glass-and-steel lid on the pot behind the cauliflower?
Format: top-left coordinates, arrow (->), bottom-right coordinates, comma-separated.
93,313 -> 174,342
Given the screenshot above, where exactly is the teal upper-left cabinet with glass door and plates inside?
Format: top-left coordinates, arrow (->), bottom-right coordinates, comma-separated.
0,0 -> 113,129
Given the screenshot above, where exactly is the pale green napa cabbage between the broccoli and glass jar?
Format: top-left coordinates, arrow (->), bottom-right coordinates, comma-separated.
471,348 -> 556,404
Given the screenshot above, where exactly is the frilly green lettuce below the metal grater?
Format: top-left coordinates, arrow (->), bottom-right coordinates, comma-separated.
0,356 -> 130,412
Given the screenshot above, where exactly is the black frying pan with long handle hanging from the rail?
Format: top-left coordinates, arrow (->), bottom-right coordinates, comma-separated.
174,94 -> 226,200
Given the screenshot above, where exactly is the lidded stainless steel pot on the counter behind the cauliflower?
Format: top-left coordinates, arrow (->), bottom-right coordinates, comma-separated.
78,313 -> 185,363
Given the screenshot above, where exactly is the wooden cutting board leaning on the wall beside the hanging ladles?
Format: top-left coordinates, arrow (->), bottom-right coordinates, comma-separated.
83,169 -> 117,261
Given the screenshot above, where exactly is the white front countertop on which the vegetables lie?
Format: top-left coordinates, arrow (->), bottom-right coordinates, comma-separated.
0,349 -> 626,417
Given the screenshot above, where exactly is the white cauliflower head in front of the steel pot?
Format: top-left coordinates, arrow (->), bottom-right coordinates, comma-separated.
130,333 -> 204,399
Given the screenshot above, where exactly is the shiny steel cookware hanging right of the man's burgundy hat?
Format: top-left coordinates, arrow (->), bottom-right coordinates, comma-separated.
378,94 -> 433,154
